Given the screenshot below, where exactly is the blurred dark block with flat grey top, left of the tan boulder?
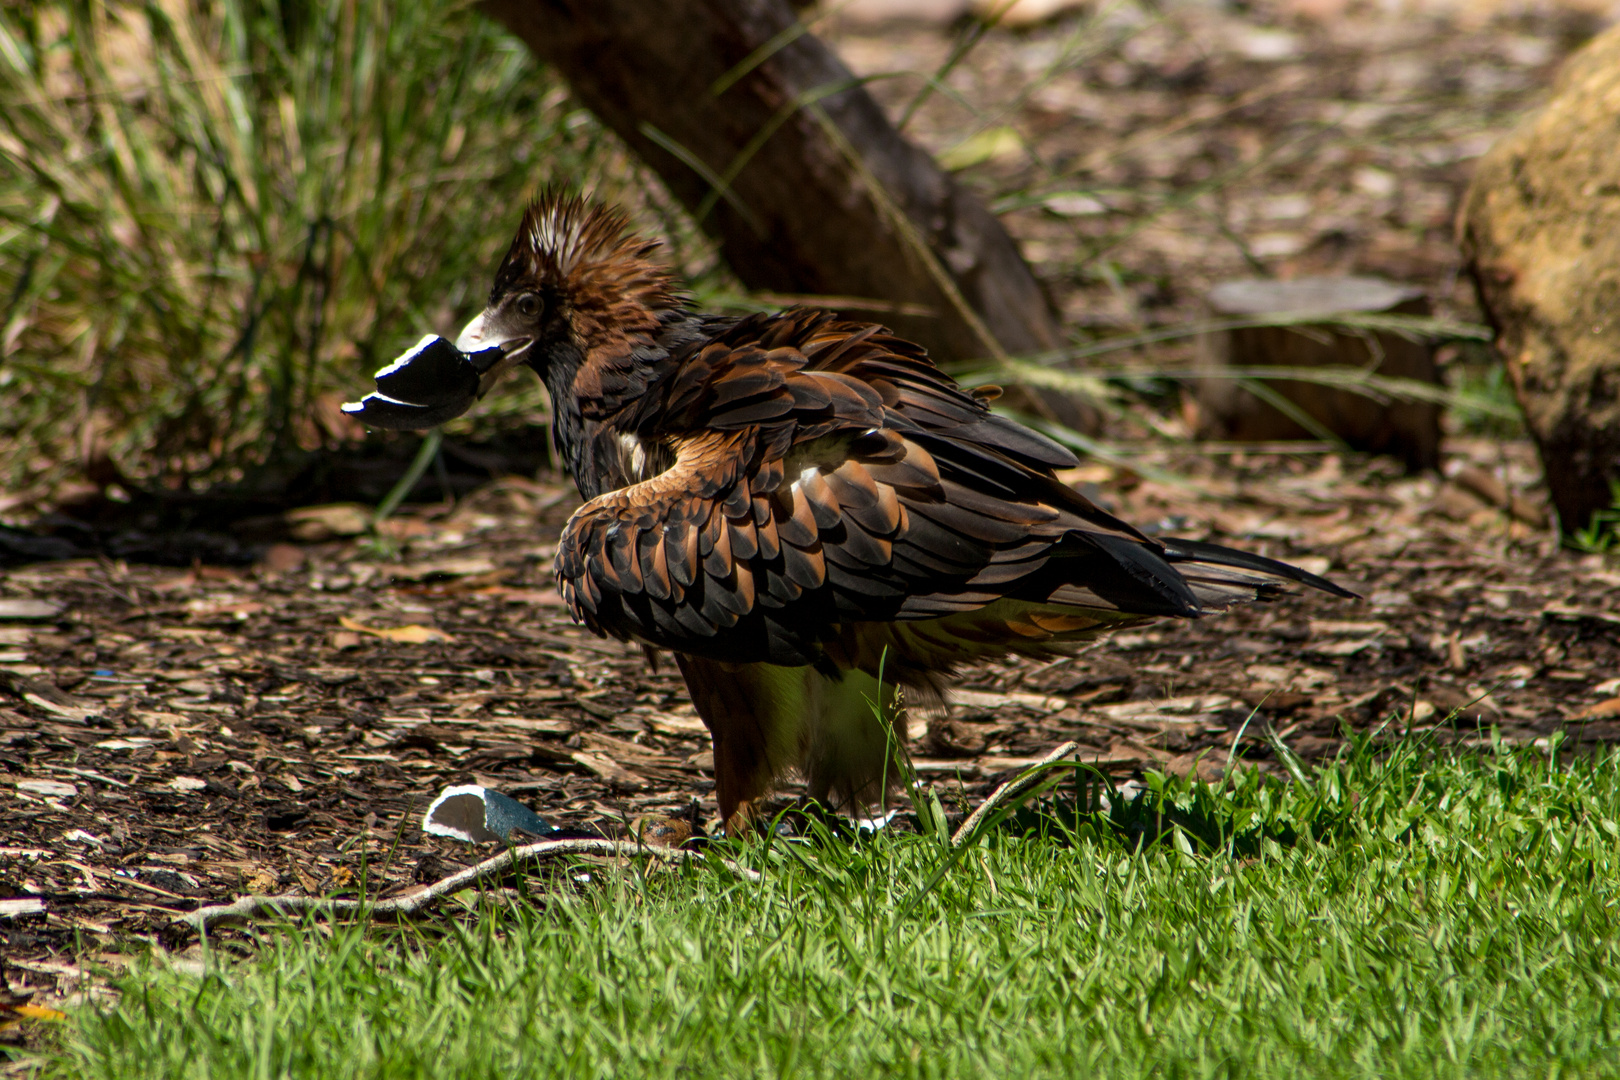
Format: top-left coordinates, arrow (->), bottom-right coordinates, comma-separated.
1197,277 -> 1440,470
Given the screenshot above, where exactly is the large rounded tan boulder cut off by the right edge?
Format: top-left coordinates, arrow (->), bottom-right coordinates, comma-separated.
1458,28 -> 1620,533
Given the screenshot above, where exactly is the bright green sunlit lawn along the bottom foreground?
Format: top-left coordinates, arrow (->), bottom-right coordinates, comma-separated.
31,743 -> 1620,1080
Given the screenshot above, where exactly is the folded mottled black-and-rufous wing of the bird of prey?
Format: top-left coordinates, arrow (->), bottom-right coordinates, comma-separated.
557,313 -> 1218,664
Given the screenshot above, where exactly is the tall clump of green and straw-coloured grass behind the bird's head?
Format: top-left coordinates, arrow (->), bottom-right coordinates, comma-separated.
0,0 -> 703,491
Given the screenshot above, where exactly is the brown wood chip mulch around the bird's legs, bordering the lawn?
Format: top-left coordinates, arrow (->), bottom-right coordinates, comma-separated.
0,440 -> 1620,1001
